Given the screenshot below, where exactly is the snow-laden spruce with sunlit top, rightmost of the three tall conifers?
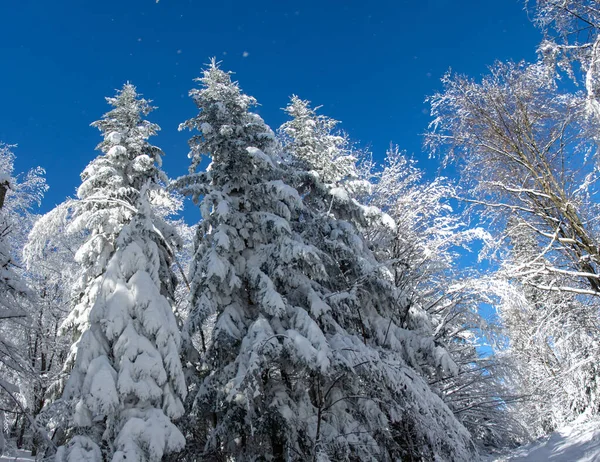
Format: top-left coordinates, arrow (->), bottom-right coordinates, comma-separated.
255,93 -> 468,460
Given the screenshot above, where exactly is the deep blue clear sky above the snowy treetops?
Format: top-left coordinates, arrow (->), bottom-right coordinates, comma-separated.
0,0 -> 540,211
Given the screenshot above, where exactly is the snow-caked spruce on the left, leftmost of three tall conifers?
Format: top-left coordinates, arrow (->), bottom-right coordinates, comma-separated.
56,84 -> 186,462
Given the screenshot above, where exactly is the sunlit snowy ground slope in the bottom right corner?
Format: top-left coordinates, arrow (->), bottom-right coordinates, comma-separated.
488,420 -> 600,462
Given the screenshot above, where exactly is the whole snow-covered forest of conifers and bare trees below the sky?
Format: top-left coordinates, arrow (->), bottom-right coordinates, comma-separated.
0,0 -> 600,462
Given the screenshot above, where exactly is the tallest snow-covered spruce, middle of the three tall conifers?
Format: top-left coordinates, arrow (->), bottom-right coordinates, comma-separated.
175,61 -> 308,460
